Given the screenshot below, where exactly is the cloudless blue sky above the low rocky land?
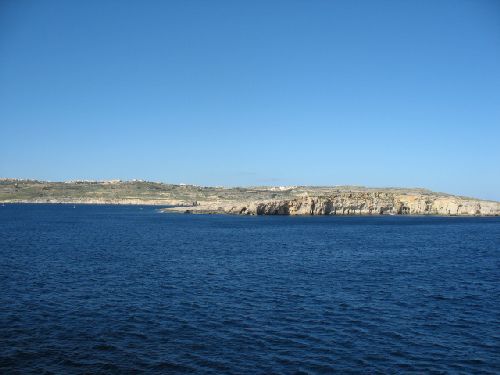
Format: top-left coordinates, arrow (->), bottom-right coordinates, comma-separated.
0,0 -> 500,200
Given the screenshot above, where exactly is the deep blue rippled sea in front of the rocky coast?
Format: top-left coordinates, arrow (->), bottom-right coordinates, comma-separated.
0,205 -> 500,374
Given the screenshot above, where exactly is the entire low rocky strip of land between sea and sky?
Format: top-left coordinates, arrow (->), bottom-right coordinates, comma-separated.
0,178 -> 500,216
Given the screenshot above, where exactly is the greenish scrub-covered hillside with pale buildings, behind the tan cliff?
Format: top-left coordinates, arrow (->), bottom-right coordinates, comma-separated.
0,179 -> 438,204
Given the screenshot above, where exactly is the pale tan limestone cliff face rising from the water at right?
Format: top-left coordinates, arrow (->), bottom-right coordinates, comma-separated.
225,192 -> 500,215
